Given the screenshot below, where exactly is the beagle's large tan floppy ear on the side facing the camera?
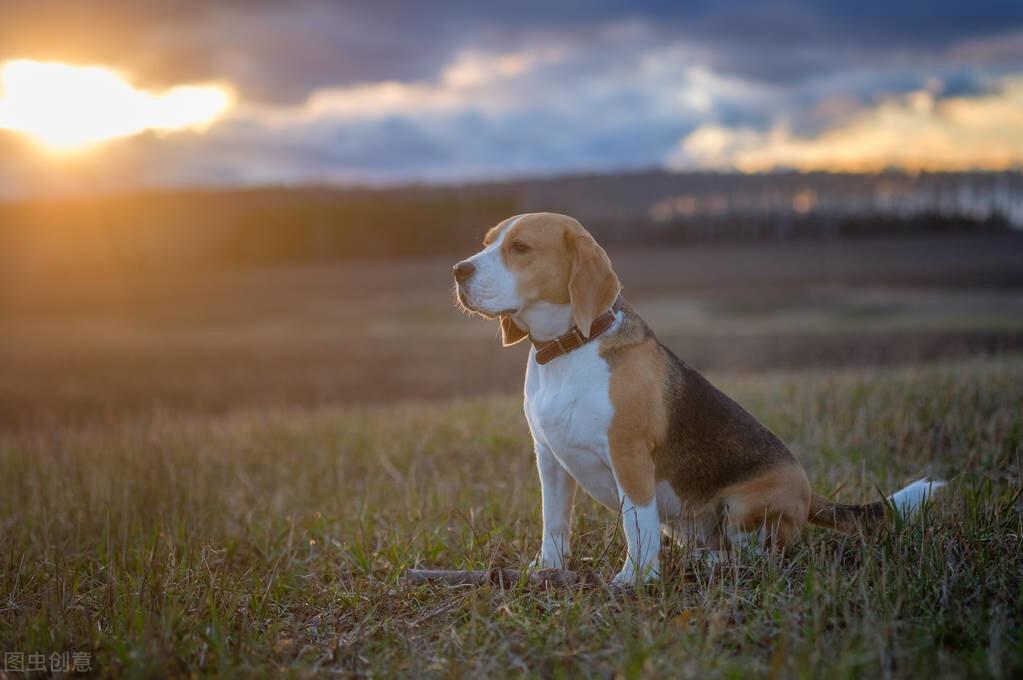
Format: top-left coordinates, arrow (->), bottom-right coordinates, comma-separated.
565,231 -> 622,337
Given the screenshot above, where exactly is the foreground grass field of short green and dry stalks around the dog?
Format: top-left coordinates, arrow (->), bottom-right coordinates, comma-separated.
0,356 -> 1023,678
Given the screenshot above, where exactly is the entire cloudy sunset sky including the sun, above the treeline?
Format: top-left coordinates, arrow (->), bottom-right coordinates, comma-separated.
0,0 -> 1023,195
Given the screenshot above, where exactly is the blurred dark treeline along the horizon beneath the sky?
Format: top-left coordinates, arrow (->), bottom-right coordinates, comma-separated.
0,172 -> 1023,272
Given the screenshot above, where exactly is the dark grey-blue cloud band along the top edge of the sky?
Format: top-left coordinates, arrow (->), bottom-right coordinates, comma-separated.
0,0 -> 1023,101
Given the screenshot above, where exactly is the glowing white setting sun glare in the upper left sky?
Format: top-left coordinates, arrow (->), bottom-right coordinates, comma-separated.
0,59 -> 232,151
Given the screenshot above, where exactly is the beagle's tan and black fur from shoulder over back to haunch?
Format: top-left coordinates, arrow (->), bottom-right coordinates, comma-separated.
601,303 -> 811,544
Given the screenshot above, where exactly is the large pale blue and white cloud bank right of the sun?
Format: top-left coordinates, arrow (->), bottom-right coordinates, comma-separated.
180,31 -> 762,182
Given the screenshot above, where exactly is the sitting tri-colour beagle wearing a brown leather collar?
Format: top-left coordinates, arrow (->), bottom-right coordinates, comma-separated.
454,213 -> 943,585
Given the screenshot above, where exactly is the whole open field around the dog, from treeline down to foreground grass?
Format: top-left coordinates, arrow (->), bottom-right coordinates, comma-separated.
0,228 -> 1023,678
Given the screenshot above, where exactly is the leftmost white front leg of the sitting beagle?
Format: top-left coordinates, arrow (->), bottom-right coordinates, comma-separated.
532,442 -> 576,569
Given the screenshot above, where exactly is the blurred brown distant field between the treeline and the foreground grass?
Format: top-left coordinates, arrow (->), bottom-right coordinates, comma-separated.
0,233 -> 1023,425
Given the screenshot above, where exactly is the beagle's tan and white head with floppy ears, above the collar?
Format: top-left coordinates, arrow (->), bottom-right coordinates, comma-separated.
454,213 -> 621,346
